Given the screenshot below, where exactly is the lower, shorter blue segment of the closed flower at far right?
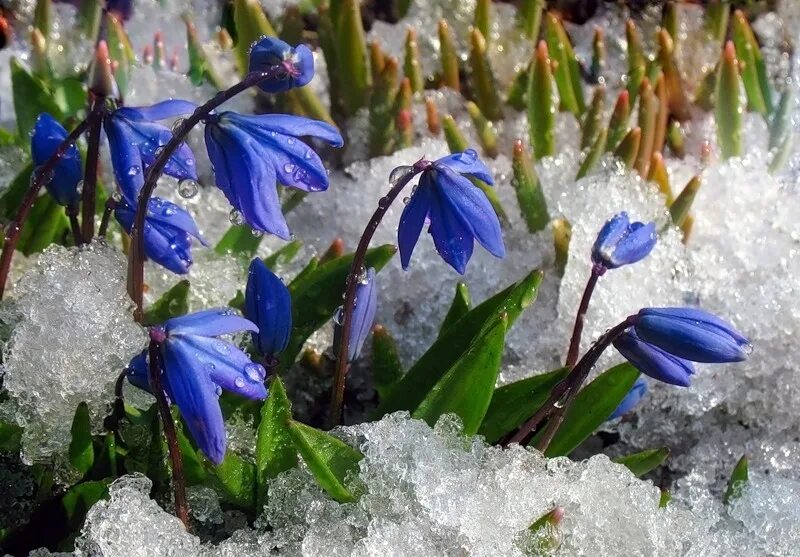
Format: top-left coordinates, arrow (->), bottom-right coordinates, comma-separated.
614,329 -> 694,387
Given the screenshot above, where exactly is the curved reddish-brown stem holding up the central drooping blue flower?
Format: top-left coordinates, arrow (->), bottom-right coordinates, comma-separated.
328,159 -> 431,427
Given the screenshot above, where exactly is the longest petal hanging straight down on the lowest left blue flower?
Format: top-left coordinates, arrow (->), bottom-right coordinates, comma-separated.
162,338 -> 227,464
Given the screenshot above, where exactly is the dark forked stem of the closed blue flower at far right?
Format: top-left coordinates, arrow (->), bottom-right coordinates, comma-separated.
503,317 -> 632,446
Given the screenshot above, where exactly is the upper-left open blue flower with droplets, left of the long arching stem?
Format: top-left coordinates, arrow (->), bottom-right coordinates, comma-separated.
104,100 -> 197,205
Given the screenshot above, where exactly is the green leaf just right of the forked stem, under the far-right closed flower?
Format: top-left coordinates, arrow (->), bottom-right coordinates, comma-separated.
545,363 -> 639,457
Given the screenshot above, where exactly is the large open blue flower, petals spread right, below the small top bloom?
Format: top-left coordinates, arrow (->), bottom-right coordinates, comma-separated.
205,112 -> 343,240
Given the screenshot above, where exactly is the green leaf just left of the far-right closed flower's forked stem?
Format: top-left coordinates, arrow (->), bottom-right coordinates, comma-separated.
478,368 -> 568,443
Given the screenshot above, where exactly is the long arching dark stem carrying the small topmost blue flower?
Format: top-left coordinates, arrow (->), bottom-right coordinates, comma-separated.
128,65 -> 286,322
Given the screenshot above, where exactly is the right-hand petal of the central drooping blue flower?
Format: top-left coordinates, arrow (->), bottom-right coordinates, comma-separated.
433,167 -> 506,257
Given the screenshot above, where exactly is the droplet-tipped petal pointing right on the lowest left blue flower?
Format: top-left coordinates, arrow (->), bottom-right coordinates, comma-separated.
180,335 -> 267,400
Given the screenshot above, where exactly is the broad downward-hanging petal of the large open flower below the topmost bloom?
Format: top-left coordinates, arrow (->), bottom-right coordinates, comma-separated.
206,124 -> 291,240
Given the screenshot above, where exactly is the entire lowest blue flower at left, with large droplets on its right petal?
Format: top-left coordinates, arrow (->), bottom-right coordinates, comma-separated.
127,308 -> 267,464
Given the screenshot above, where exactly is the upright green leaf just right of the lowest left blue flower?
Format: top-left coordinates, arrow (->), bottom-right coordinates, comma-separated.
256,375 -> 297,505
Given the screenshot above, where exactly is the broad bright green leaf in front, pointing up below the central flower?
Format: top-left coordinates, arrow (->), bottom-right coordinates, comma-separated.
414,315 -> 508,435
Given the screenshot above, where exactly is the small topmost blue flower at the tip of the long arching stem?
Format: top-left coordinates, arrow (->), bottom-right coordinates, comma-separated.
248,37 -> 314,93
